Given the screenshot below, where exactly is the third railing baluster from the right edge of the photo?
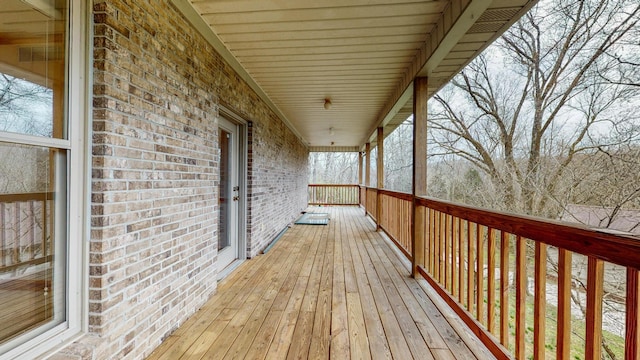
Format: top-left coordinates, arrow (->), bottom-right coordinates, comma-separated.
556,248 -> 571,359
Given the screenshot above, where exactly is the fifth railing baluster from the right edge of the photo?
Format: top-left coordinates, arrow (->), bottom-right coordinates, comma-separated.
515,236 -> 527,359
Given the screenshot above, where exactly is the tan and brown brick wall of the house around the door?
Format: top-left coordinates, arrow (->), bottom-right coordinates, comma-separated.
55,0 -> 307,359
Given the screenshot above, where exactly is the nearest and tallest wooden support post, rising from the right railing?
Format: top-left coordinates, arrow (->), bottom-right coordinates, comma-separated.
411,77 -> 432,277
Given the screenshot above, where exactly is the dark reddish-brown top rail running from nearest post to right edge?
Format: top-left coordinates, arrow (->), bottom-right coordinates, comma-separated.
416,197 -> 640,269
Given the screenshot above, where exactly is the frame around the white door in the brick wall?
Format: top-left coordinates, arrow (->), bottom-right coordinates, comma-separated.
218,105 -> 249,280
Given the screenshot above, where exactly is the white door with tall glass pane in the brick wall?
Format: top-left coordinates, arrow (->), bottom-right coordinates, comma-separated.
218,118 -> 240,270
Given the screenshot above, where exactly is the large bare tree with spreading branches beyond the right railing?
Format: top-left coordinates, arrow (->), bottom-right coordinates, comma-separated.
430,0 -> 640,218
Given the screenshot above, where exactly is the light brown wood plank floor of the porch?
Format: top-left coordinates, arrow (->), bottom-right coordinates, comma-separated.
149,207 -> 491,360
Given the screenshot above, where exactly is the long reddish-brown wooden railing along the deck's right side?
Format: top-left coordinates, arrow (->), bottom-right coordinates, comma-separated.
362,187 -> 640,360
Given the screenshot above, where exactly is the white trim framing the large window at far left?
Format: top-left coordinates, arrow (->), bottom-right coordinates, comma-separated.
0,0 -> 92,360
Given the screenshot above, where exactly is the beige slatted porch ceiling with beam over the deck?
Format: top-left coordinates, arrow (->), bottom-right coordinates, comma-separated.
173,0 -> 535,151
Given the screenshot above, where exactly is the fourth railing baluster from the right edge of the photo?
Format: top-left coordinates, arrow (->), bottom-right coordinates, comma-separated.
533,242 -> 547,359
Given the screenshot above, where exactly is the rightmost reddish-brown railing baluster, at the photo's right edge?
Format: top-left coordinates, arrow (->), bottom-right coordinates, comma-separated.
624,268 -> 640,360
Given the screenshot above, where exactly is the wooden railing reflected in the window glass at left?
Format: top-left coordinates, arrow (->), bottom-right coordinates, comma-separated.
0,193 -> 52,274
